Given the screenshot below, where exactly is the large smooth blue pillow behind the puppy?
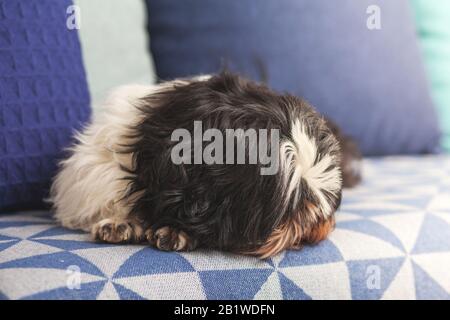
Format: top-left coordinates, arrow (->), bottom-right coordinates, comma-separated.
147,0 -> 440,155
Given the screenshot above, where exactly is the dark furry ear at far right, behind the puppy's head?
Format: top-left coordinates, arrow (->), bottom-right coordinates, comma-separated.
325,119 -> 362,188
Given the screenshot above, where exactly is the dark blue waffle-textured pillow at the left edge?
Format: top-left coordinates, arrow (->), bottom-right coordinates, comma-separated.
0,0 -> 90,210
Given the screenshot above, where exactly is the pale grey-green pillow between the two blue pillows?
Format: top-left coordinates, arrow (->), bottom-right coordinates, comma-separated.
74,0 -> 155,111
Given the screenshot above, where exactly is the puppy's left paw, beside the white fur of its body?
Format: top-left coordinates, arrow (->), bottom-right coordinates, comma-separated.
92,219 -> 142,243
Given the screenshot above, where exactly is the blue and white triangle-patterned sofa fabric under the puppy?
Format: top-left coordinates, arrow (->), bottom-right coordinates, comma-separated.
0,156 -> 450,299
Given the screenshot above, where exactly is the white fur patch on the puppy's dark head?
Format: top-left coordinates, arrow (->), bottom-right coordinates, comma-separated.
280,119 -> 342,218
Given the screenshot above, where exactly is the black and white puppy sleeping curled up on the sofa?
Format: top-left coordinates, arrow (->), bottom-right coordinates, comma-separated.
50,73 -> 361,258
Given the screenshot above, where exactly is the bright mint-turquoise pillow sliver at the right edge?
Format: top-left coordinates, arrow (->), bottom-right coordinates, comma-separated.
411,0 -> 450,152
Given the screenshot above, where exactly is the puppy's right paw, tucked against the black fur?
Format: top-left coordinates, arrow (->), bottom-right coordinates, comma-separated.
145,227 -> 196,251
